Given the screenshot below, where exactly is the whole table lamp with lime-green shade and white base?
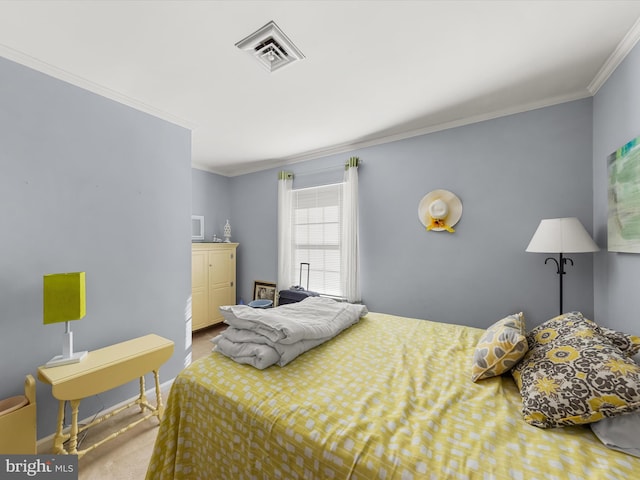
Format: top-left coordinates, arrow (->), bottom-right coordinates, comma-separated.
43,272 -> 87,367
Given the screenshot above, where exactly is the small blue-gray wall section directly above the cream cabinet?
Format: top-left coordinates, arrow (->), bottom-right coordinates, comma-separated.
191,168 -> 234,242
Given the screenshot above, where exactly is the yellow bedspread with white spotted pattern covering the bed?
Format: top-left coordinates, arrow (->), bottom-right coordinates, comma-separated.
147,313 -> 640,480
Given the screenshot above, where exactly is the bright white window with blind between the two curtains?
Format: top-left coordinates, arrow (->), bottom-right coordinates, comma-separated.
291,183 -> 344,297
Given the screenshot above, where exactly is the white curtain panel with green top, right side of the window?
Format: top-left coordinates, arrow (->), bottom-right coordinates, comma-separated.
340,157 -> 362,302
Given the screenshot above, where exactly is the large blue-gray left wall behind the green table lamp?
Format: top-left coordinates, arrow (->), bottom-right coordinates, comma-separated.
0,58 -> 191,438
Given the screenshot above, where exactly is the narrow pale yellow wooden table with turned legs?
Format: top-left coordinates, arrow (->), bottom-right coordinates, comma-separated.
38,334 -> 173,458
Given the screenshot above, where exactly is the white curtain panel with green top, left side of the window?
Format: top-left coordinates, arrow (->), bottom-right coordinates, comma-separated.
277,171 -> 295,291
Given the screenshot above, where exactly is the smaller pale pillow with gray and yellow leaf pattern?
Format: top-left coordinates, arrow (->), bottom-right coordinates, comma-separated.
471,312 -> 528,382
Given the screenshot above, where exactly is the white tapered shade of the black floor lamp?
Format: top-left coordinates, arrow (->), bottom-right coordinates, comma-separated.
526,217 -> 600,253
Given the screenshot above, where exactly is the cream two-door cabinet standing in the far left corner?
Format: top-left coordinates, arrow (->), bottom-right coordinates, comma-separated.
191,243 -> 238,330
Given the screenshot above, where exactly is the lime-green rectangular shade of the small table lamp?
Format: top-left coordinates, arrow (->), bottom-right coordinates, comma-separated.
43,272 -> 86,325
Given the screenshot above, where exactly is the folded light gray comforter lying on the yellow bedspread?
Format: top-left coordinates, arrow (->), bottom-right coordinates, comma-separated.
212,297 -> 368,370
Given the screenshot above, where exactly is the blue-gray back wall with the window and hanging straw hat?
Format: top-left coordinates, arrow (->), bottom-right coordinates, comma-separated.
231,99 -> 594,328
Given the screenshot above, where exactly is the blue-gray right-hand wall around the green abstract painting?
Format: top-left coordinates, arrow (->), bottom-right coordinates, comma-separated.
593,40 -> 640,334
